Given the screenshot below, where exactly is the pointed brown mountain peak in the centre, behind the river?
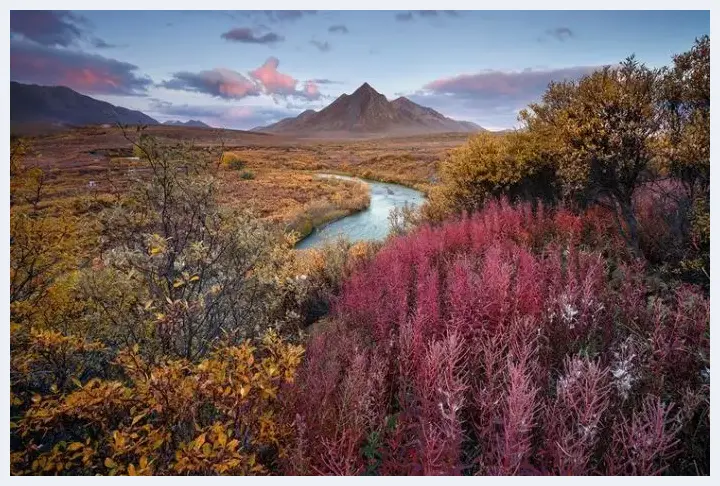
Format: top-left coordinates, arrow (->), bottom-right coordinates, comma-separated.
253,83 -> 484,136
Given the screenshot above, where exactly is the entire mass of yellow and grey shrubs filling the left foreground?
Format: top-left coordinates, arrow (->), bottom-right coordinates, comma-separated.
10,135 -> 304,474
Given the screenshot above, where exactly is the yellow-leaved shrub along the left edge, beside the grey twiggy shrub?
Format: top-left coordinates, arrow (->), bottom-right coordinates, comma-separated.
10,142 -> 102,405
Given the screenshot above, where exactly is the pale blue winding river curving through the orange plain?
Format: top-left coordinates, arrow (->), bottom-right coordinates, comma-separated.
295,174 -> 425,249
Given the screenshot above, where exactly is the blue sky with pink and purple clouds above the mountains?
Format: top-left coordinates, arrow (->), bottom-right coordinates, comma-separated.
10,10 -> 710,130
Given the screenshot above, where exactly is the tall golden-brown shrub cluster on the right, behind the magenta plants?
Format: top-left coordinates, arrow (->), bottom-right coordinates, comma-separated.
425,36 -> 710,285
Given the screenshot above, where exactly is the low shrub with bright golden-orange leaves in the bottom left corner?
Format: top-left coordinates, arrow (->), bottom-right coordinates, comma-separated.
11,333 -> 302,475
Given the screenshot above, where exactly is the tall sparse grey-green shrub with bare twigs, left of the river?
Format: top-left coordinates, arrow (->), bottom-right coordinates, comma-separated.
80,135 -> 306,361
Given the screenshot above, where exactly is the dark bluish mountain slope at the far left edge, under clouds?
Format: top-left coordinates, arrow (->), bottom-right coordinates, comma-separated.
10,81 -> 158,125
